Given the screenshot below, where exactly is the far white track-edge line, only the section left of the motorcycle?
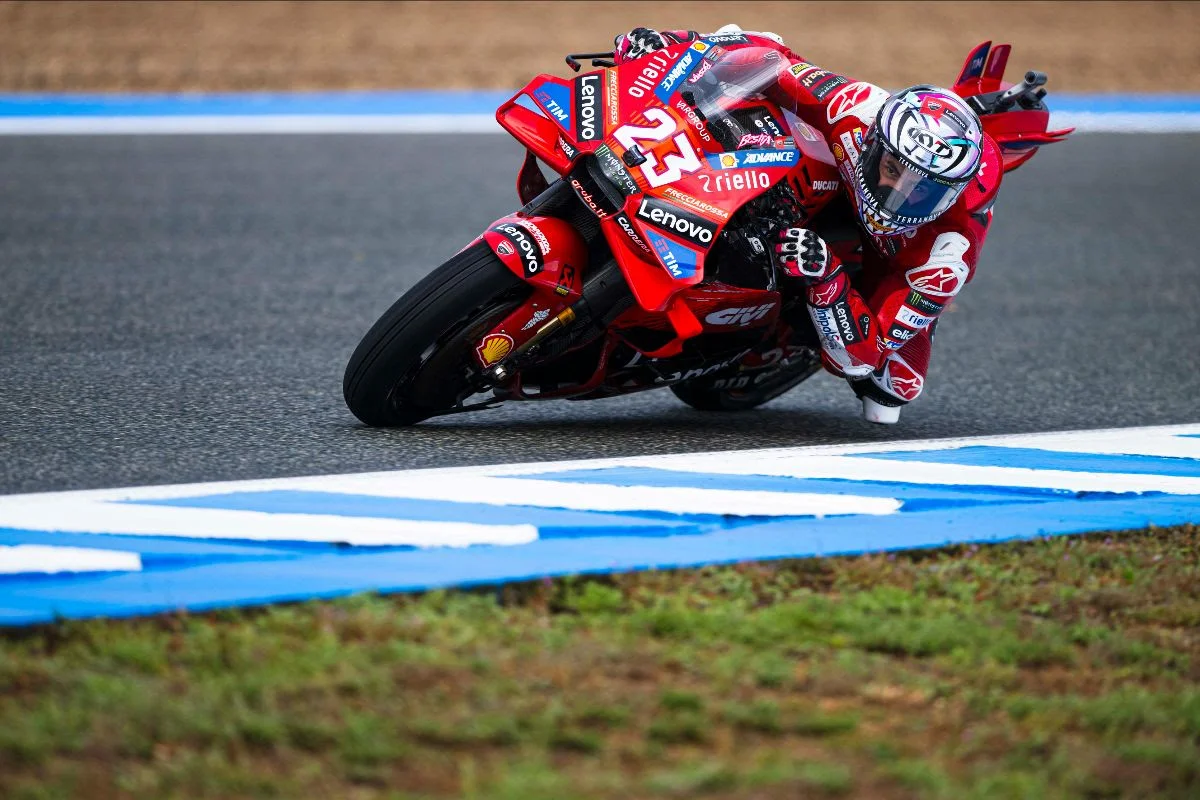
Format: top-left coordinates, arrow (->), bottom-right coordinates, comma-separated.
0,114 -> 504,136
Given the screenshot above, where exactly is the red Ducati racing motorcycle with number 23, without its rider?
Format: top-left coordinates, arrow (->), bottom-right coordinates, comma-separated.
343,37 -> 1068,426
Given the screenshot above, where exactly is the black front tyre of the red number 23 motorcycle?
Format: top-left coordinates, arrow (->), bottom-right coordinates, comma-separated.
342,242 -> 529,427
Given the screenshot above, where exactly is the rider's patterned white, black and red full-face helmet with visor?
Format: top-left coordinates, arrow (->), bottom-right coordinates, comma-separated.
854,85 -> 983,236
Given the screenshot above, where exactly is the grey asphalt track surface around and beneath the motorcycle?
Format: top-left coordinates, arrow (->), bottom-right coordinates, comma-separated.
0,134 -> 1200,493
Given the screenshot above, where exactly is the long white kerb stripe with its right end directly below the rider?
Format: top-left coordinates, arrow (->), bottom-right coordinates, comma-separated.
309,475 -> 901,519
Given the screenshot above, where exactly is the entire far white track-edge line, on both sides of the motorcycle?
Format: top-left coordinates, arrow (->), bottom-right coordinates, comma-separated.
0,112 -> 1200,136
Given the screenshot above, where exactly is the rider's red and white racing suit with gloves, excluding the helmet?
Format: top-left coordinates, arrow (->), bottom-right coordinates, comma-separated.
617,26 -> 1001,422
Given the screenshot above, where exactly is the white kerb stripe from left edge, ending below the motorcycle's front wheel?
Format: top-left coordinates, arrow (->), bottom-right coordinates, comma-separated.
0,499 -> 538,547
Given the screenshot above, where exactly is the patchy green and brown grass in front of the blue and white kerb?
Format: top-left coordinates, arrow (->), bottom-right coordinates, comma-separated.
0,527 -> 1200,800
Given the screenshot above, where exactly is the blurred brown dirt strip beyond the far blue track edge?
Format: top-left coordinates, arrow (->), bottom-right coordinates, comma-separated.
0,1 -> 1200,91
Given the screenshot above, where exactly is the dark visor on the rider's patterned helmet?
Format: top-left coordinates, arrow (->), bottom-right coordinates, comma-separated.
862,137 -> 966,227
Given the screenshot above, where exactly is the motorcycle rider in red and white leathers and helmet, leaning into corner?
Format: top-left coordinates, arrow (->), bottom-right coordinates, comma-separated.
614,25 -> 1001,423
